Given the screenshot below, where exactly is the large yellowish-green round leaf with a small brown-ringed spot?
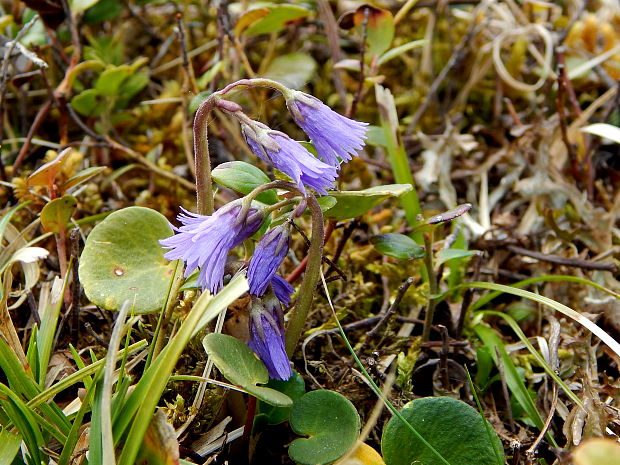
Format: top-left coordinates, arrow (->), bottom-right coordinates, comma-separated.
79,207 -> 175,313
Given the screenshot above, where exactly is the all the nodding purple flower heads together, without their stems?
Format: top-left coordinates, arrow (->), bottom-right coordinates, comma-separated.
160,91 -> 367,380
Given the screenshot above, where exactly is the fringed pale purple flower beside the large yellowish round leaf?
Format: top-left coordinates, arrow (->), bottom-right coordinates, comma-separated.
159,201 -> 264,294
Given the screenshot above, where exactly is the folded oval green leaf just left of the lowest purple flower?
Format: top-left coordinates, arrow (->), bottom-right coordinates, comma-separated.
202,333 -> 293,407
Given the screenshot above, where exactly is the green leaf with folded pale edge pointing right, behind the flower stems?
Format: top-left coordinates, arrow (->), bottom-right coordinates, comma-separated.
325,184 -> 413,221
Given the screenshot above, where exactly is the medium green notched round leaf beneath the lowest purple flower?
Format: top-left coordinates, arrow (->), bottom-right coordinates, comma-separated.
288,390 -> 360,465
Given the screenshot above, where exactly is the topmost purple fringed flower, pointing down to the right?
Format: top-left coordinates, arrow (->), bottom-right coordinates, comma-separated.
286,91 -> 368,168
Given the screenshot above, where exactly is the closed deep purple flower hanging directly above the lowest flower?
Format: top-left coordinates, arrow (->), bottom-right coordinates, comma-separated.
248,224 -> 290,297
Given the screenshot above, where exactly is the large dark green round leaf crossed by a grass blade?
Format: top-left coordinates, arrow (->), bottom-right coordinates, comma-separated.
381,397 -> 504,465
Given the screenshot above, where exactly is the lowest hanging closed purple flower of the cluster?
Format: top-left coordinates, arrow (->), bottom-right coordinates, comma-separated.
248,292 -> 292,381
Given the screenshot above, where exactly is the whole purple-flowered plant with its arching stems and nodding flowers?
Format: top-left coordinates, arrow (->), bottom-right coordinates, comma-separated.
160,79 -> 367,380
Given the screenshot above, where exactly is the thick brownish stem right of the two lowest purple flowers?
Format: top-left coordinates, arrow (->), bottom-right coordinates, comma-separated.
286,194 -> 323,357
